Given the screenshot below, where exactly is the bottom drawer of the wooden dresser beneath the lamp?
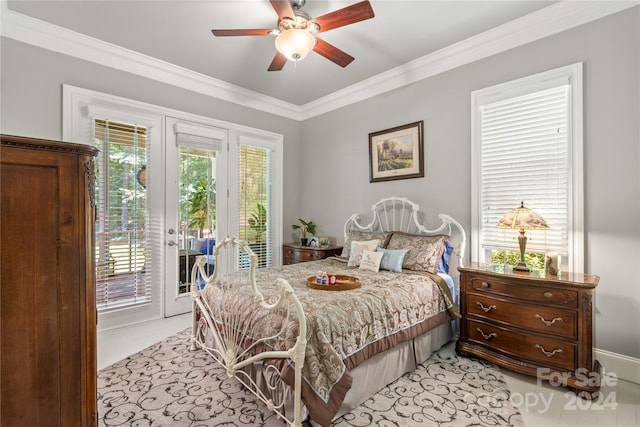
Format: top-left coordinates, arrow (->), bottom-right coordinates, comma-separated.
467,320 -> 576,371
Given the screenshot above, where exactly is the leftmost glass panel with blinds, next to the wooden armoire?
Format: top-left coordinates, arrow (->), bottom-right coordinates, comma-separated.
93,119 -> 151,311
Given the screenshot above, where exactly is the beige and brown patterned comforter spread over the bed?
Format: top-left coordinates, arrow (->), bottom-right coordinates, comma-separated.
203,258 -> 458,425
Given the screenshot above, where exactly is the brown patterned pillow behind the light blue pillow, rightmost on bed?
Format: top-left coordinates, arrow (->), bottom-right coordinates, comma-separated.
387,232 -> 449,274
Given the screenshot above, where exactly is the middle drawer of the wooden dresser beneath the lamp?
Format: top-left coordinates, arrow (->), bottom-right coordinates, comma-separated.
467,293 -> 578,339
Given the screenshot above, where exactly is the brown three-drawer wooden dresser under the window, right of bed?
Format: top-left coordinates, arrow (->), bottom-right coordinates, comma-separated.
456,264 -> 602,398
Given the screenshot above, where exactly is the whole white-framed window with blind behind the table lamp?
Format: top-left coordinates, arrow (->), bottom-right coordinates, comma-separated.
472,63 -> 582,271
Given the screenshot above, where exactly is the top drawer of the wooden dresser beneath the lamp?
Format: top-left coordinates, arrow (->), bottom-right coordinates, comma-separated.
467,277 -> 578,307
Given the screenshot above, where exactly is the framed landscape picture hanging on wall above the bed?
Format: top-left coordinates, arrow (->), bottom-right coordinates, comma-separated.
369,120 -> 424,182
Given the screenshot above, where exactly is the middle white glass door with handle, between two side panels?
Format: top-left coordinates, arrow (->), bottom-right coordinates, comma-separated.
164,117 -> 228,316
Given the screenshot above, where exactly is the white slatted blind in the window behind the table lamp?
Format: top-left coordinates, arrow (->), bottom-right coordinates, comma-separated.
480,84 -> 570,255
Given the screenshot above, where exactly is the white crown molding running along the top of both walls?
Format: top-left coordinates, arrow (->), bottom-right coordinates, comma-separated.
0,0 -> 640,121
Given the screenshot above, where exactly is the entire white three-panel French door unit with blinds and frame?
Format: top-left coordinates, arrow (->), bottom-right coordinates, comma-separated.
63,85 -> 283,330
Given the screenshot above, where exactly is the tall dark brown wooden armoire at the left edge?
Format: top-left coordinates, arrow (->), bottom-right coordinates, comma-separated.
0,135 -> 97,427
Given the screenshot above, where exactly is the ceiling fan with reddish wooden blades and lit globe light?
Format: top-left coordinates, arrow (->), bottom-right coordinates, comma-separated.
211,0 -> 374,71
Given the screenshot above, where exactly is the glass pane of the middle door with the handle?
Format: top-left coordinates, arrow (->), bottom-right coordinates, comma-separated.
178,147 -> 216,294
